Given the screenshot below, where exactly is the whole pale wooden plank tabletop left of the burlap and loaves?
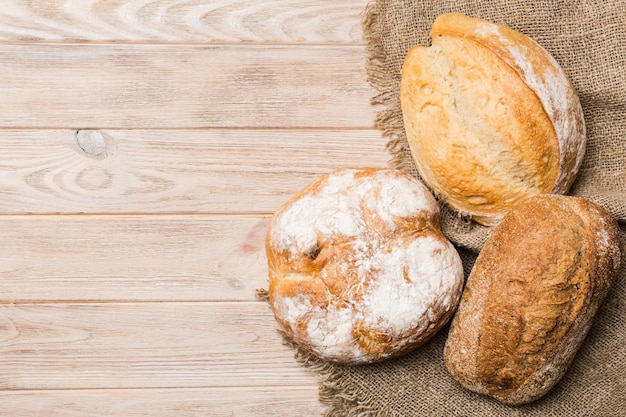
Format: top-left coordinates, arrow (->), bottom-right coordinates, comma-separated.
0,0 -> 389,417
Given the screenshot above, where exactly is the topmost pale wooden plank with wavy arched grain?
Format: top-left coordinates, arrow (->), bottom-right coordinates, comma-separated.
0,0 -> 367,43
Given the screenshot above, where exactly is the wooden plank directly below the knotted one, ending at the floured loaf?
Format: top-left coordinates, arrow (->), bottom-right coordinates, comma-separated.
0,216 -> 268,302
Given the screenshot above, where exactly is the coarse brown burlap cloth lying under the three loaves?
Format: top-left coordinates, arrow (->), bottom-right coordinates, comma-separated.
270,0 -> 626,417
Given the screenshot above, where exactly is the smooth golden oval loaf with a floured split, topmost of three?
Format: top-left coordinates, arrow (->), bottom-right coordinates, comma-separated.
400,13 -> 585,226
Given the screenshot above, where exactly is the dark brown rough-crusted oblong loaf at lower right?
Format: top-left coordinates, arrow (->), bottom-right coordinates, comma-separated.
444,195 -> 621,404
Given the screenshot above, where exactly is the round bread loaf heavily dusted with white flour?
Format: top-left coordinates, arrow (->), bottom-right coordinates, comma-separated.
266,168 -> 464,364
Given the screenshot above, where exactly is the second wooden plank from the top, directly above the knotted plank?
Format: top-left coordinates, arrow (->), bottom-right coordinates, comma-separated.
0,44 -> 375,129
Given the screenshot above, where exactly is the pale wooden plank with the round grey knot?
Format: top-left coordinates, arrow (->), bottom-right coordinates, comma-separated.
0,130 -> 389,214
